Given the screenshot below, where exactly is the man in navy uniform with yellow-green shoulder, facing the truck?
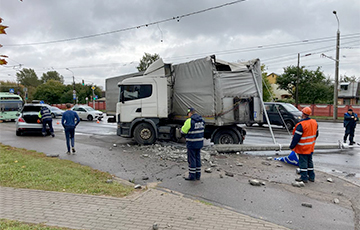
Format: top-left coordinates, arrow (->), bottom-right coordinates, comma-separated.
181,108 -> 205,180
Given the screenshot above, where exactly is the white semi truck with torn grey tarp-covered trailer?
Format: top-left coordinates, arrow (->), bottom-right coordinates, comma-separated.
112,55 -> 263,145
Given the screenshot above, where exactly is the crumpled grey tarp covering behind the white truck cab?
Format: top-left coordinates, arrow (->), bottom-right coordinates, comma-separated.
171,56 -> 262,125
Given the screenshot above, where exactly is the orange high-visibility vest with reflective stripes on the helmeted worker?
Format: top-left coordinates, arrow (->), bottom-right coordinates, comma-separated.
293,119 -> 318,154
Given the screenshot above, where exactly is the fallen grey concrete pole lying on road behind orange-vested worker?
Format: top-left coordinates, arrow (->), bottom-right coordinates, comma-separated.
214,143 -> 341,153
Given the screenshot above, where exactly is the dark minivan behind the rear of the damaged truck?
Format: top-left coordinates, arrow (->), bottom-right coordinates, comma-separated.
246,102 -> 301,130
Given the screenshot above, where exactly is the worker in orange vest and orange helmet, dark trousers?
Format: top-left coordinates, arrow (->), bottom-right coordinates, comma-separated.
290,107 -> 319,183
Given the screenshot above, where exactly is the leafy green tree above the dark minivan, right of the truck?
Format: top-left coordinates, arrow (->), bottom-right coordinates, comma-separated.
277,66 -> 334,104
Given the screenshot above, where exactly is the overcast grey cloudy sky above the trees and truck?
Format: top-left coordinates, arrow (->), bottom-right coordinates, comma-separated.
0,0 -> 360,88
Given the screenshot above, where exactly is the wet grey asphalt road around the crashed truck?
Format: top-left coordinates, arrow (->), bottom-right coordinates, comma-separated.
0,119 -> 360,230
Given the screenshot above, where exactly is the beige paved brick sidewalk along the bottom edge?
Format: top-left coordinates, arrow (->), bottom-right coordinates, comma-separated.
0,187 -> 287,230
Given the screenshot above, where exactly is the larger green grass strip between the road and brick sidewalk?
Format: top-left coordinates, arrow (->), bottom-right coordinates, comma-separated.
0,143 -> 134,197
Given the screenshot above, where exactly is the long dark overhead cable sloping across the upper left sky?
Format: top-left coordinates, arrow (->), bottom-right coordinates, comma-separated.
3,0 -> 246,47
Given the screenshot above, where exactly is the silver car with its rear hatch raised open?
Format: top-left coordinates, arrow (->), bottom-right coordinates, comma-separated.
15,104 -> 50,136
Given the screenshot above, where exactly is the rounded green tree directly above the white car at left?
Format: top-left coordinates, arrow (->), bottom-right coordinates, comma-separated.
34,79 -> 65,104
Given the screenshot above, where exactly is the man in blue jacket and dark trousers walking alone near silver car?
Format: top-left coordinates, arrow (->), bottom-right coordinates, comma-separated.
61,103 -> 80,155
